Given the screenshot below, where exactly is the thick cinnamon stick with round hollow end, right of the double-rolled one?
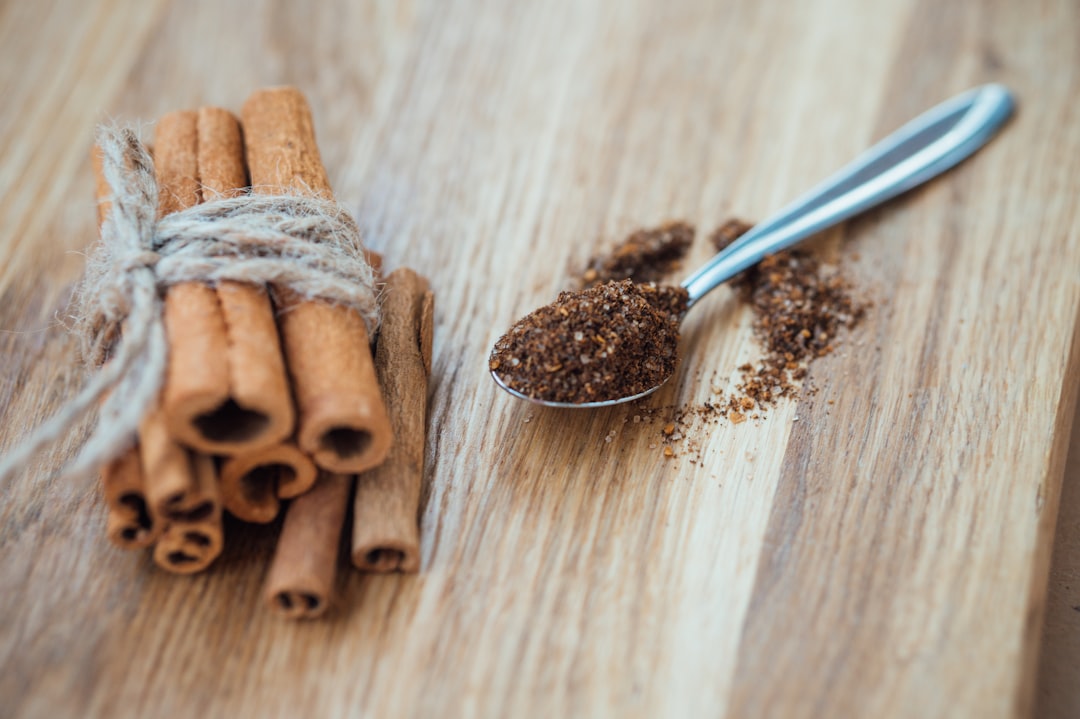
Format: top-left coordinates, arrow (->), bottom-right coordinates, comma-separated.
242,87 -> 392,473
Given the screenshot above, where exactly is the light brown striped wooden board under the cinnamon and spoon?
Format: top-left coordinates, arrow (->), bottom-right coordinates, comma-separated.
0,0 -> 1080,719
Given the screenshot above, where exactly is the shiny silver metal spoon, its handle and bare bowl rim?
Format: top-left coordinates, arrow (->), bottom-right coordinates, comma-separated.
491,84 -> 1014,408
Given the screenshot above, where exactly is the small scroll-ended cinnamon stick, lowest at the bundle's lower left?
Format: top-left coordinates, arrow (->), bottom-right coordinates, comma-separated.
153,449 -> 225,574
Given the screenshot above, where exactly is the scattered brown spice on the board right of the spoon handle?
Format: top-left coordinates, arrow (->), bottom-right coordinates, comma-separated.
728,249 -> 865,408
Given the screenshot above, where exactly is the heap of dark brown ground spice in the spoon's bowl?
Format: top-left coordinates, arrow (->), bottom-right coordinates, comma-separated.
488,280 -> 687,404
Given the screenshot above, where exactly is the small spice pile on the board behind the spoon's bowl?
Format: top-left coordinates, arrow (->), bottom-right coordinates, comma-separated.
581,221 -> 694,287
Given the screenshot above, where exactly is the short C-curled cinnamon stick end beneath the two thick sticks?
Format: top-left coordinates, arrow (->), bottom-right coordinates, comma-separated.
220,443 -> 316,524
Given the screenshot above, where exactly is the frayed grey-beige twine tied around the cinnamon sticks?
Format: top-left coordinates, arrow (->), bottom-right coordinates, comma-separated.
0,126 -> 378,479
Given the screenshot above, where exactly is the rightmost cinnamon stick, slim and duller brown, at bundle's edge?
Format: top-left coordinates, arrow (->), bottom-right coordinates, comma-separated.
352,268 -> 434,572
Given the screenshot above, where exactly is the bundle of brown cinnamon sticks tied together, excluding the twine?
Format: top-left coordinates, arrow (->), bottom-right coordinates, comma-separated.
95,87 -> 433,618
